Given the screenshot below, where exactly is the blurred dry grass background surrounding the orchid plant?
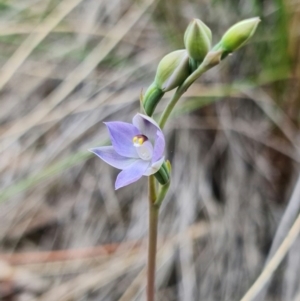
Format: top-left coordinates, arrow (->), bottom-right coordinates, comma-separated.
0,0 -> 300,301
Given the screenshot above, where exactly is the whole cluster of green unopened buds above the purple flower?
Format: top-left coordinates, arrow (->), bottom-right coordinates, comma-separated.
143,17 -> 260,116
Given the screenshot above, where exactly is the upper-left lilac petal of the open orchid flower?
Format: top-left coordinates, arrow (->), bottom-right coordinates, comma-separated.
105,121 -> 141,158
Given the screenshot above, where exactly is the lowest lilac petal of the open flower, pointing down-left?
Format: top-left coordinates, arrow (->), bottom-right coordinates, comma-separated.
115,160 -> 150,190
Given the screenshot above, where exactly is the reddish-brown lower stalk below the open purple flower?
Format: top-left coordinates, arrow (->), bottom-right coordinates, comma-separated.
147,176 -> 159,301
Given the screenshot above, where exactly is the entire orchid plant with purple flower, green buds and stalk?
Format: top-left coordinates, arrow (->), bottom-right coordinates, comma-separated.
90,18 -> 260,301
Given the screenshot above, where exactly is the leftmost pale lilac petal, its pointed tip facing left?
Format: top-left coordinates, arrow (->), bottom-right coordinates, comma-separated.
89,146 -> 136,169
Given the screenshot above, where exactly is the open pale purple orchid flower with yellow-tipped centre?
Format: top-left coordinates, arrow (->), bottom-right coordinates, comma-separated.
90,114 -> 165,189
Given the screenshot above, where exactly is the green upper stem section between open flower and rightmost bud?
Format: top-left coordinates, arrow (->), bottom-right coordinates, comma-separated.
159,51 -> 221,129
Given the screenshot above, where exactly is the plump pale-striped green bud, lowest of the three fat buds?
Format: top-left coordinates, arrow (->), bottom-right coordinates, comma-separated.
154,49 -> 189,92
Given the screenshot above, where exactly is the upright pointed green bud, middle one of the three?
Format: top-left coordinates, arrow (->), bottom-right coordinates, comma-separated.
184,19 -> 212,62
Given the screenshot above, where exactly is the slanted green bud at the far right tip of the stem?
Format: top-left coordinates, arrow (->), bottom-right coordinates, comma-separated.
218,17 -> 260,53
